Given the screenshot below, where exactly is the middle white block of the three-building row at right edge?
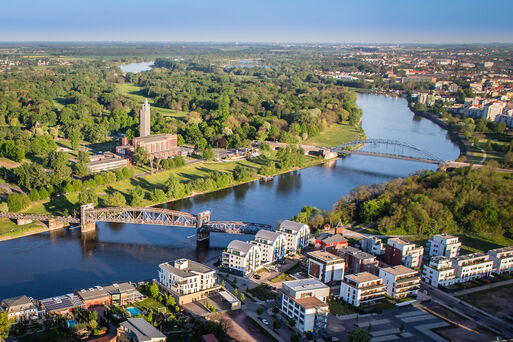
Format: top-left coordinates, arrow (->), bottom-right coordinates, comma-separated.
452,253 -> 493,283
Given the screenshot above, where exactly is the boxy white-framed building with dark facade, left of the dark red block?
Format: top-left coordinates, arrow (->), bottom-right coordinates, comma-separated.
306,251 -> 345,284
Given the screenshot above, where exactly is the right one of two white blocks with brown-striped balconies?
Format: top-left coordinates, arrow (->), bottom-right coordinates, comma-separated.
379,265 -> 420,299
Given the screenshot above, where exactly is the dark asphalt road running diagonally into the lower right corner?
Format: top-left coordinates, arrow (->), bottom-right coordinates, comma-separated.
421,282 -> 513,338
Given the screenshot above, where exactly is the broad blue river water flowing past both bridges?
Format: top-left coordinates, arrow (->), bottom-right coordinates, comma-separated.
0,95 -> 459,298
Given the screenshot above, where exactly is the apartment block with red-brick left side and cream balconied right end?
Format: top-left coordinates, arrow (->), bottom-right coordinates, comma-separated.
383,238 -> 424,268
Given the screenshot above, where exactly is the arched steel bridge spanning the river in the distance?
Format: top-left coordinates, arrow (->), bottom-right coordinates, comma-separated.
330,139 -> 444,164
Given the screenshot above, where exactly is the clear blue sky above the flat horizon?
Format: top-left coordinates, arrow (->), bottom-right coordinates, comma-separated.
0,0 -> 513,43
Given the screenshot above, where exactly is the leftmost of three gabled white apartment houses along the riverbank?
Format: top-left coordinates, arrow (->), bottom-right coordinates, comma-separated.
222,240 -> 262,277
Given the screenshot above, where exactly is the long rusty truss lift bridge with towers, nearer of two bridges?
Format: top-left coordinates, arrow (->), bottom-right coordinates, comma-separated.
0,203 -> 274,241
